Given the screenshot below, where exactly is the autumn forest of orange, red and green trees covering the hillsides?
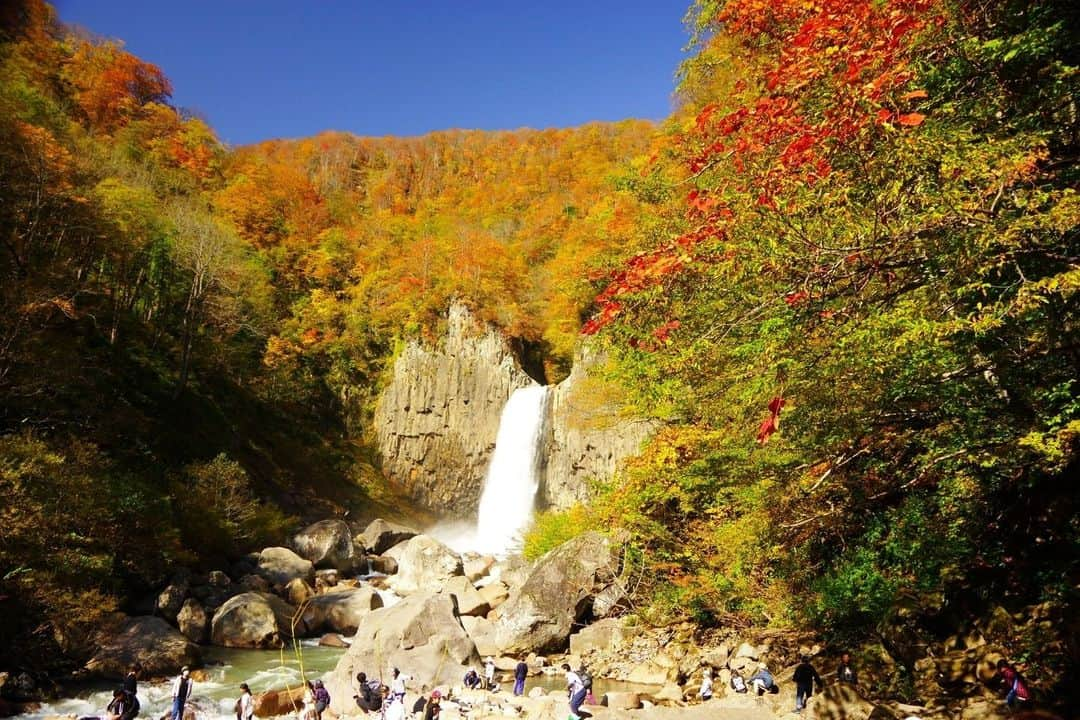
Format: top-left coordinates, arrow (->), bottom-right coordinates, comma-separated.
0,0 -> 1080,708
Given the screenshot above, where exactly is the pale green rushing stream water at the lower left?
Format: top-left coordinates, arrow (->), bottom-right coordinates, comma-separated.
18,640 -> 345,720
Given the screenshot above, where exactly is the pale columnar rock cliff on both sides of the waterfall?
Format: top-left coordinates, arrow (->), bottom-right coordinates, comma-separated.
375,304 -> 657,517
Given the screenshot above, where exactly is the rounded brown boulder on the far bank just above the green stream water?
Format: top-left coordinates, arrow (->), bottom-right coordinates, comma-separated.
211,593 -> 307,648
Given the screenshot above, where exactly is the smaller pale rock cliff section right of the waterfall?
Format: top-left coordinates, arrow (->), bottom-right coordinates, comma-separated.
538,347 -> 658,510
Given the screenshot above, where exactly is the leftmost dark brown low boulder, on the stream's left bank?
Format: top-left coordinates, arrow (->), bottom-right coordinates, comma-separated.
86,615 -> 202,679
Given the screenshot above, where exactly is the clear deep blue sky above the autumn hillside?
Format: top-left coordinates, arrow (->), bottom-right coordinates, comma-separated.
55,0 -> 689,145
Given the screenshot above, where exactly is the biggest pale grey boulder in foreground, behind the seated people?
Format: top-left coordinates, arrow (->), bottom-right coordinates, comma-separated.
324,595 -> 481,715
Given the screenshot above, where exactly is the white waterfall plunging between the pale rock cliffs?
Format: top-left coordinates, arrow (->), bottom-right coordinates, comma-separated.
475,385 -> 548,556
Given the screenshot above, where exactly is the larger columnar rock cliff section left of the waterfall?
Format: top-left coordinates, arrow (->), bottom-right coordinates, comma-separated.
375,304 -> 536,515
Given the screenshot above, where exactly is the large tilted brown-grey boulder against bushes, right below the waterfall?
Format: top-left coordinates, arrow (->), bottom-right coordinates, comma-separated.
496,532 -> 620,655
